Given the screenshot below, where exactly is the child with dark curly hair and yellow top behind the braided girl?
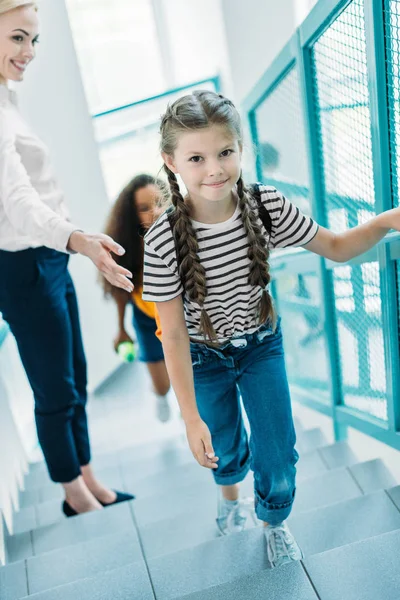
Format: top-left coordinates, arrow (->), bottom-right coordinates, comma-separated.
102,174 -> 171,422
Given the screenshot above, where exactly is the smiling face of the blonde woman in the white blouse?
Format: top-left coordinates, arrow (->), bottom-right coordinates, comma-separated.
0,5 -> 39,84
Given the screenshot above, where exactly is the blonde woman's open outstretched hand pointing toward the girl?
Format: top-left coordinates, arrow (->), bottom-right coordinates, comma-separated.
68,231 -> 133,293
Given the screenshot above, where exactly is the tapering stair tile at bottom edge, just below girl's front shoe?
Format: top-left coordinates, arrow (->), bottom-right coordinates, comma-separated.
176,562 -> 318,600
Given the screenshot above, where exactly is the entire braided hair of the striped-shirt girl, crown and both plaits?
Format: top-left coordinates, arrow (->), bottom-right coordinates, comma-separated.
160,90 -> 275,341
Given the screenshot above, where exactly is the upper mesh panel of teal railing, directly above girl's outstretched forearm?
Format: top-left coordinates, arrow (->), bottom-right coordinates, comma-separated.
313,0 -> 375,231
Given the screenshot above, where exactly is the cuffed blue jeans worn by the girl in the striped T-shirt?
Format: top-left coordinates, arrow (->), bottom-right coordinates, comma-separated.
190,321 -> 299,525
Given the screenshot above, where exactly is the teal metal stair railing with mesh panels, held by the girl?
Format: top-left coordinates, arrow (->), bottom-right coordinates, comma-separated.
244,0 -> 400,449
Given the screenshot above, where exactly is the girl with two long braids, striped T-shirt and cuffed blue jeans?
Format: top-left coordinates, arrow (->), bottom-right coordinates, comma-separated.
143,91 -> 400,567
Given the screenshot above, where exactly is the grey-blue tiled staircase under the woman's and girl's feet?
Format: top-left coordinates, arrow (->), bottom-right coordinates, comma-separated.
0,414 -> 400,600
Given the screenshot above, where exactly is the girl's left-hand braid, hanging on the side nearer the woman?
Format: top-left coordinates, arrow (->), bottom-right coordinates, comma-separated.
164,165 -> 217,340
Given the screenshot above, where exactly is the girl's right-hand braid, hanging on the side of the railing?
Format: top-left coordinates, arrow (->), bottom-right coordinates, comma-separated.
237,176 -> 276,328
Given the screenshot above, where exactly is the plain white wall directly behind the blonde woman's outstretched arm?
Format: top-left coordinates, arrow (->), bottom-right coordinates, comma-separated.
17,0 -> 118,388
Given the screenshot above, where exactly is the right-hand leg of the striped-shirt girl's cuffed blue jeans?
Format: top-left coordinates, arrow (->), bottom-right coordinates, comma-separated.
239,327 -> 298,525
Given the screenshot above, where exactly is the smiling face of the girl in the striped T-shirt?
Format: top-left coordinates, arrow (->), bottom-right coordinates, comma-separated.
163,125 -> 242,202
